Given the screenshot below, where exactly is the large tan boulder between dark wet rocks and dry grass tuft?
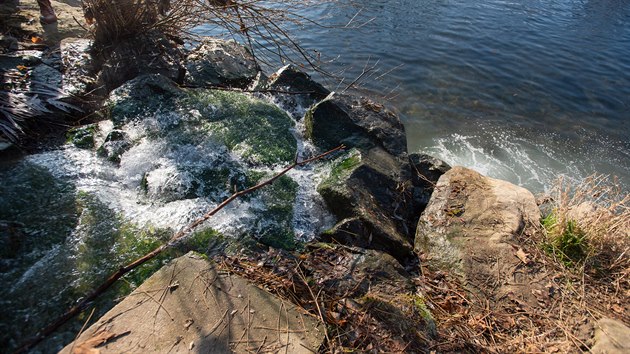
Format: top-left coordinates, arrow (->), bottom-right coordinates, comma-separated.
415,166 -> 542,305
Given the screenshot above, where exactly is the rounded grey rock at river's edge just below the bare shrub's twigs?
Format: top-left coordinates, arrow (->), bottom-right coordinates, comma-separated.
185,38 -> 260,88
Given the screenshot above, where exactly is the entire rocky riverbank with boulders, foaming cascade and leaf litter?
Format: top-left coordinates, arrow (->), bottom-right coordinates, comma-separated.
0,3 -> 629,353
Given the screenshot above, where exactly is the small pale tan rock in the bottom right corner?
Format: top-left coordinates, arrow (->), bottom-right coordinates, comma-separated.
591,318 -> 630,354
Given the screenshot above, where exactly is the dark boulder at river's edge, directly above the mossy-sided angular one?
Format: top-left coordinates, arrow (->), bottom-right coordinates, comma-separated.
305,93 -> 407,156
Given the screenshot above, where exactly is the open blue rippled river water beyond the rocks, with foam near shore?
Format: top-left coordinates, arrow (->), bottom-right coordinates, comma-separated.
249,0 -> 630,192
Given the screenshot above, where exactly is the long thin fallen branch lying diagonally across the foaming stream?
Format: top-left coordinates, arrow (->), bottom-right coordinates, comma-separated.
14,145 -> 345,353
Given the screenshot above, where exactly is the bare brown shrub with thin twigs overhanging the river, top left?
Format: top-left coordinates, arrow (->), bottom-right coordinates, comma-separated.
83,0 -> 346,74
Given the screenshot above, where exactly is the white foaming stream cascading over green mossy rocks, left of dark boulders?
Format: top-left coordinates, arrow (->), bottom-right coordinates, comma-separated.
0,83 -> 334,352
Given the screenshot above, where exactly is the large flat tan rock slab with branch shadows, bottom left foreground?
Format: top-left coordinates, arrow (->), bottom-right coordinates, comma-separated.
61,253 -> 324,354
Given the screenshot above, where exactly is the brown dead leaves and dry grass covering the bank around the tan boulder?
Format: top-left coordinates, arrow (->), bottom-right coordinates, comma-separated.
221,176 -> 630,353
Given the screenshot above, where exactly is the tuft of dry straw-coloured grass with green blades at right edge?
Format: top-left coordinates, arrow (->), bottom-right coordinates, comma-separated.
542,175 -> 630,290
